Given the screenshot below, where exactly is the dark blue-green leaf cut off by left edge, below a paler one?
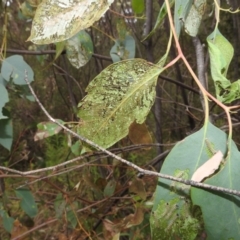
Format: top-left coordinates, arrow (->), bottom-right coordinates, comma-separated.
0,108 -> 13,151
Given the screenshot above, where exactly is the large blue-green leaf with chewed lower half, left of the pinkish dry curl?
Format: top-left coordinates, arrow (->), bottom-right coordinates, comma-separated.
151,123 -> 232,239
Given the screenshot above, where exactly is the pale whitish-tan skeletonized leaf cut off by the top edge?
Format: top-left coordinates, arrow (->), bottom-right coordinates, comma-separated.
28,0 -> 113,44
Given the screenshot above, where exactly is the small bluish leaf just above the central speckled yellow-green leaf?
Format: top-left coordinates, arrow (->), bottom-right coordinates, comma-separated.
110,35 -> 135,62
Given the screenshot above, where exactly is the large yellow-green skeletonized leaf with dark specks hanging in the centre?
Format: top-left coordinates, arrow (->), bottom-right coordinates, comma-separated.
77,59 -> 162,148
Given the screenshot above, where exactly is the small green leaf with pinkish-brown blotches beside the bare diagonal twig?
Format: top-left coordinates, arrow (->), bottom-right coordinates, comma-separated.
34,119 -> 64,141
